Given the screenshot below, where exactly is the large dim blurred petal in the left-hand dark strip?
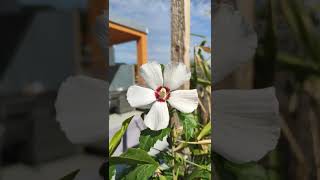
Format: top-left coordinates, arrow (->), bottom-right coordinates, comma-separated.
55,76 -> 108,144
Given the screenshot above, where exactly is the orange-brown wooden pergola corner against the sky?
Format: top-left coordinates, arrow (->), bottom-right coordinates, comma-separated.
109,20 -> 147,66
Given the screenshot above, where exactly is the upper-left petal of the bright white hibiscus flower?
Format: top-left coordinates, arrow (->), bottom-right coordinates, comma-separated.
140,62 -> 163,90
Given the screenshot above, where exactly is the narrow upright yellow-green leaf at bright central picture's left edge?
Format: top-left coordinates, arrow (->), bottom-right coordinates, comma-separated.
109,116 -> 134,157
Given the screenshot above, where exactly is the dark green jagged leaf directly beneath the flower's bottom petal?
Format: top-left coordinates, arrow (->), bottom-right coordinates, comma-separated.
139,128 -> 171,151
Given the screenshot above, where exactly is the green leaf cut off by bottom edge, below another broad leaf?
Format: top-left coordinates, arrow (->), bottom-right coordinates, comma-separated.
125,164 -> 158,180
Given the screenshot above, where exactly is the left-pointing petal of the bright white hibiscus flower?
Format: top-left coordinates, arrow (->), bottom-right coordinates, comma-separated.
127,85 -> 156,107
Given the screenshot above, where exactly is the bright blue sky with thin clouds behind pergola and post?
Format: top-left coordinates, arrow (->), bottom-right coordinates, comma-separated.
109,0 -> 211,64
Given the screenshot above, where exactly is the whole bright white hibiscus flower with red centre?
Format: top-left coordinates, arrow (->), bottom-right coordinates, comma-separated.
127,62 -> 198,131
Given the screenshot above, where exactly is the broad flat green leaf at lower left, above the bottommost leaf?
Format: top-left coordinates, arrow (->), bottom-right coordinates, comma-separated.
110,148 -> 159,166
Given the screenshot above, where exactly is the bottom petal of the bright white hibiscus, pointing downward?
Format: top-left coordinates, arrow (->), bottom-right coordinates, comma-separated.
144,101 -> 169,131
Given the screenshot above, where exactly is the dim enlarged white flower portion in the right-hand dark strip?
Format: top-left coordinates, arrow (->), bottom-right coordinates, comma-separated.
212,4 -> 280,163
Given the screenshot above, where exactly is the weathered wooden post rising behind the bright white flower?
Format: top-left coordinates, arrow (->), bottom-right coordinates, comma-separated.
171,0 -> 190,89
